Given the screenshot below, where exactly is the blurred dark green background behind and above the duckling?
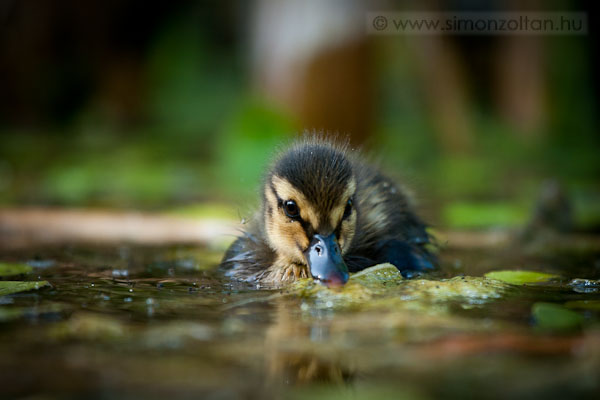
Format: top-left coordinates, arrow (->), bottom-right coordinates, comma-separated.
0,0 -> 600,231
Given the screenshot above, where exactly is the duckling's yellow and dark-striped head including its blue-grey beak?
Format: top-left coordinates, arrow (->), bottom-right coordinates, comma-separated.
263,142 -> 357,286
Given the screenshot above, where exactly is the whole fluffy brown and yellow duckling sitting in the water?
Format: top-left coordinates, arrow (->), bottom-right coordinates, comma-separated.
221,137 -> 436,287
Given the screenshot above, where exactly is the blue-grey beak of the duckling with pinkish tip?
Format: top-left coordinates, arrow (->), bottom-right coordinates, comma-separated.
304,234 -> 349,287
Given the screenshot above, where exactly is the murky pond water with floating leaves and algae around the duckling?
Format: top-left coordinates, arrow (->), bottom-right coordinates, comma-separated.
0,239 -> 600,399
